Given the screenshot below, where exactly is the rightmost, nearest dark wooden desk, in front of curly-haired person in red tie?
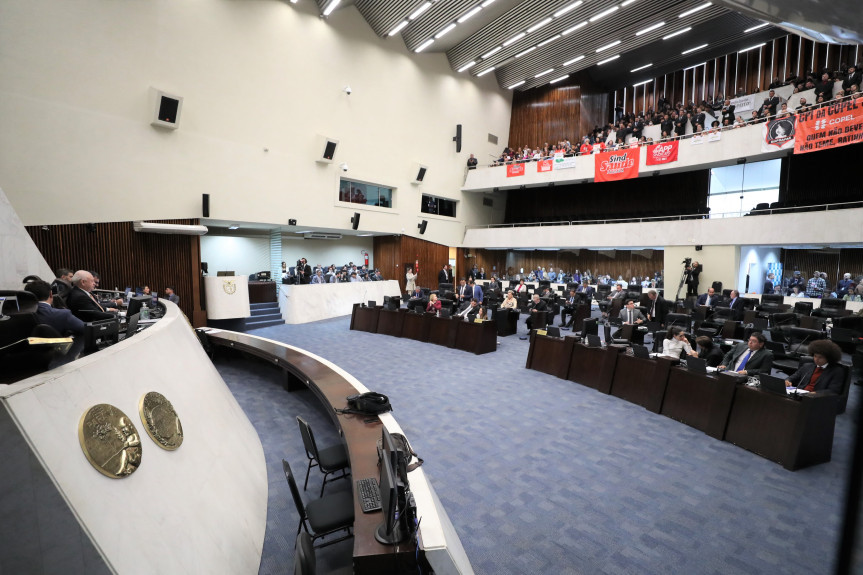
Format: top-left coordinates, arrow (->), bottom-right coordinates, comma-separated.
725,385 -> 839,471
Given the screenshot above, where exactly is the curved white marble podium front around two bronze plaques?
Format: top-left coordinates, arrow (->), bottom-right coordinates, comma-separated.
0,300 -> 267,575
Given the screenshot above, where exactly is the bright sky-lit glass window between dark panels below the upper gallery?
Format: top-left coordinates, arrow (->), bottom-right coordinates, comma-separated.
707,160 -> 782,218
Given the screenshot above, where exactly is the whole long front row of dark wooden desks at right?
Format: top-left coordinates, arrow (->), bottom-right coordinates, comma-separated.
527,333 -> 839,471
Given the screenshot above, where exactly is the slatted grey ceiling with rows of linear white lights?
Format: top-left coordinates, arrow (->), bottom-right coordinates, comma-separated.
316,0 -> 863,91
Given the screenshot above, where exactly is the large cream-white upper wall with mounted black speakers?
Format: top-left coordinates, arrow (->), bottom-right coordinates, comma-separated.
0,0 -> 511,245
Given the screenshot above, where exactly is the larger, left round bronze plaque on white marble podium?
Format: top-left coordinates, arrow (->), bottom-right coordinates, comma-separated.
78,403 -> 141,479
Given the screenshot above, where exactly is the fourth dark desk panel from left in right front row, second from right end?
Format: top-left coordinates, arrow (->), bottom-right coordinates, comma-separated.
660,367 -> 738,439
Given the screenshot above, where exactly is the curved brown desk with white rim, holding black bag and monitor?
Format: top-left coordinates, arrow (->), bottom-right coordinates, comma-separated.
206,330 -> 473,574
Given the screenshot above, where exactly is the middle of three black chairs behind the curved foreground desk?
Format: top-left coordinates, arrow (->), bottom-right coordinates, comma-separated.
282,459 -> 354,547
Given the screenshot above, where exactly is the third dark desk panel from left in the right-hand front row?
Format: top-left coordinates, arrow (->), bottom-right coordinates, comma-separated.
611,353 -> 671,413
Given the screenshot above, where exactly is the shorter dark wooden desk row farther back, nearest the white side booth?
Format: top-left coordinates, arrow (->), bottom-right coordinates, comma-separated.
351,303 -> 497,355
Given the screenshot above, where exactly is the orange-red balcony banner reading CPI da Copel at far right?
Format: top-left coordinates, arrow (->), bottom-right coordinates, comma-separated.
794,98 -> 863,154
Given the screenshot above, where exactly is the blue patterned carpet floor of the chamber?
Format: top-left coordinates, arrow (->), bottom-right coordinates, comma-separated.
216,318 -> 860,575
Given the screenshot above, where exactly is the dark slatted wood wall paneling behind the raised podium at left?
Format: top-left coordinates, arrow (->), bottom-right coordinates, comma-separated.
27,219 -> 206,326
